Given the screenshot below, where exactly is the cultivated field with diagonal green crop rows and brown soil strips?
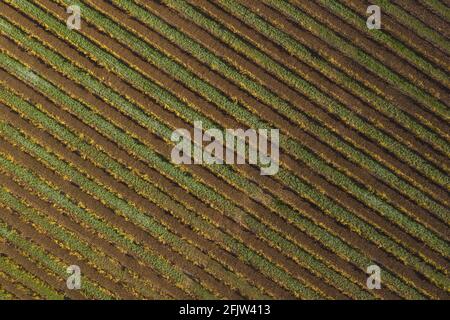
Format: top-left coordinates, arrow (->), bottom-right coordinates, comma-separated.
0,0 -> 450,299
